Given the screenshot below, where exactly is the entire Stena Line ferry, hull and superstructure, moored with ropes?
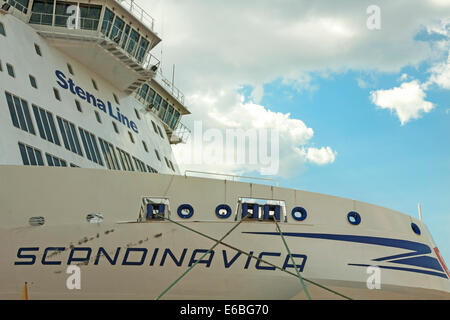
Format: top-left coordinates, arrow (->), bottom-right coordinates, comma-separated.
0,0 -> 450,300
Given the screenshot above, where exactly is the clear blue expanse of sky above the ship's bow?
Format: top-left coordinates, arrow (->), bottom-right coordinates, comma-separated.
244,68 -> 450,261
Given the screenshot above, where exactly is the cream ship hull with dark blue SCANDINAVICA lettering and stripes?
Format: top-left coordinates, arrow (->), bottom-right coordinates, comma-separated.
0,166 -> 450,300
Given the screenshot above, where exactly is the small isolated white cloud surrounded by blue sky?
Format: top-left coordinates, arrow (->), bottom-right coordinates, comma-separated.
370,80 -> 434,125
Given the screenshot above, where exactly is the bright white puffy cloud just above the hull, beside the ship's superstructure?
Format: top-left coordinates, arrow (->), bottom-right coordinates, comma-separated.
174,91 -> 337,177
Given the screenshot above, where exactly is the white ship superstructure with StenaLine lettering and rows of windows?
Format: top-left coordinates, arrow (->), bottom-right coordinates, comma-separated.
0,0 -> 189,173
